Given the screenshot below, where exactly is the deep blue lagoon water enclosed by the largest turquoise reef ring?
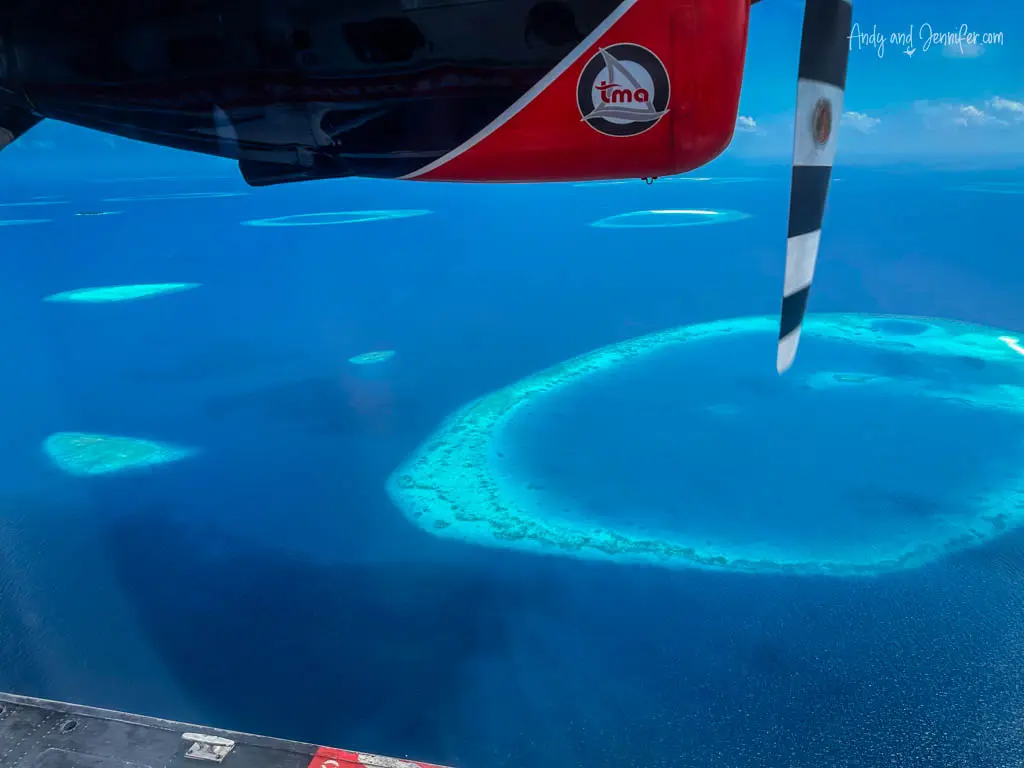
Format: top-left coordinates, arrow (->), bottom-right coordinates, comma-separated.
500,327 -> 1024,562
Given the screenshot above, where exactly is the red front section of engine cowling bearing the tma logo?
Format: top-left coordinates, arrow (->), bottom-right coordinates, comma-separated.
407,0 -> 749,181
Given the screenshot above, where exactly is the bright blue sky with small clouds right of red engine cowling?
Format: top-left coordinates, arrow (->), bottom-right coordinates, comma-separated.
729,0 -> 1024,166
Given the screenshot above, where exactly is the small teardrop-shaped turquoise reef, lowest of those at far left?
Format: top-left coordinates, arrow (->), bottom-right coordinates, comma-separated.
43,432 -> 199,477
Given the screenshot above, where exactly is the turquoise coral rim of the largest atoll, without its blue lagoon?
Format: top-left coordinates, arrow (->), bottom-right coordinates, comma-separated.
387,314 -> 1024,575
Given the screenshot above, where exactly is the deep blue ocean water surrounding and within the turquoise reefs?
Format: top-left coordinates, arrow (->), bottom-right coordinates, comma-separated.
0,167 -> 1024,768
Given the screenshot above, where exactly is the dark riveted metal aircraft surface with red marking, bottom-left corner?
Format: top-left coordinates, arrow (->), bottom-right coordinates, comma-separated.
0,693 -> 452,768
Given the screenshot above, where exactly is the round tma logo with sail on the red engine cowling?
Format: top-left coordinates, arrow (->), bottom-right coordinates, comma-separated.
577,43 -> 669,136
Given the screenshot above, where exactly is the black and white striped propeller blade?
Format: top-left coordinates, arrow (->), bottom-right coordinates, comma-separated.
776,0 -> 853,374
